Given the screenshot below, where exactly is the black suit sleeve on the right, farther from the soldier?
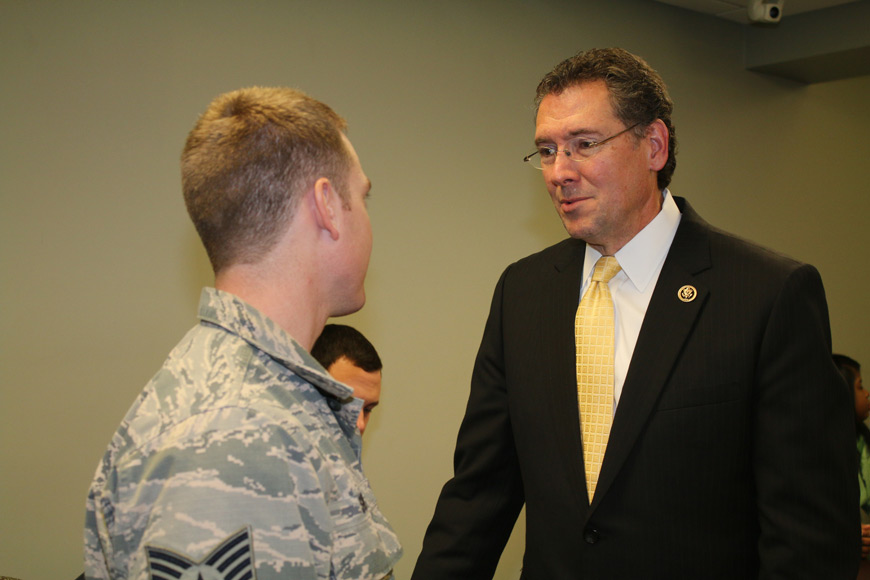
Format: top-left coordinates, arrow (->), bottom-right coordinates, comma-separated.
753,265 -> 859,580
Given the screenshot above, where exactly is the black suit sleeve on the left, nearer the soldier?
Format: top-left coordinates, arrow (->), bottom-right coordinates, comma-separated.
412,268 -> 523,580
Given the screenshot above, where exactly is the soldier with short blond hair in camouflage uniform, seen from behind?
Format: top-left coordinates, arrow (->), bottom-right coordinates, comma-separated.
85,88 -> 401,580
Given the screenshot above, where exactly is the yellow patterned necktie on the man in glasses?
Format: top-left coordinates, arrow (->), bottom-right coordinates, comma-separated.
574,256 -> 621,502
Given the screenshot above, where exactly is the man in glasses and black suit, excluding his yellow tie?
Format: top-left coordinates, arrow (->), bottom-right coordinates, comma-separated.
413,49 -> 859,580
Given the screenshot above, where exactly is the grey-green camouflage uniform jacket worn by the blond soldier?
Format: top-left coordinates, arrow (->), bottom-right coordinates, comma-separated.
85,288 -> 402,580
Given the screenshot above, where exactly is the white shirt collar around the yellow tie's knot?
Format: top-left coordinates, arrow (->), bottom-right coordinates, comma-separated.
583,189 -> 682,292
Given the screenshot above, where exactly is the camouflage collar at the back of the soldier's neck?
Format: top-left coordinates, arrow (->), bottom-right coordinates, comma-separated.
199,288 -> 353,399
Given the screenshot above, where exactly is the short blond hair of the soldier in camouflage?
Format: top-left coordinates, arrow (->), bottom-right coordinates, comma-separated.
181,87 -> 352,273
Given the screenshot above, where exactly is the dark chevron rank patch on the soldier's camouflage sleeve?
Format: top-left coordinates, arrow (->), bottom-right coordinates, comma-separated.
145,528 -> 257,580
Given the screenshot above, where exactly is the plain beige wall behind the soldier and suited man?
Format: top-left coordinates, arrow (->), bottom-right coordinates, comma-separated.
0,0 -> 870,580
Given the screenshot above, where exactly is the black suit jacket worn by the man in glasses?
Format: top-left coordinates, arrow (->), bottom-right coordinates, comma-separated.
412,198 -> 859,580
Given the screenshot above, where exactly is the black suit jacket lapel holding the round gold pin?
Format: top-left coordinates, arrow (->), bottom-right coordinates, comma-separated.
590,198 -> 710,511
